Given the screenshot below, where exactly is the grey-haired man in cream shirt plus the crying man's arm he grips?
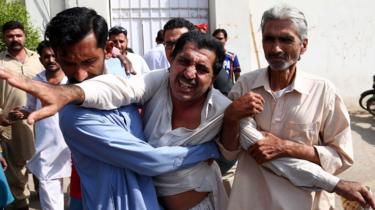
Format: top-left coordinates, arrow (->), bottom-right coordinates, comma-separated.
222,5 -> 374,210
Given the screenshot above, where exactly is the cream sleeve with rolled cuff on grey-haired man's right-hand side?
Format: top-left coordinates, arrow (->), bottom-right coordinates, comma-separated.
315,86 -> 353,174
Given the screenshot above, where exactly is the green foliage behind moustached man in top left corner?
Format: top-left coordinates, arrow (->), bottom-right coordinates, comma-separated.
0,0 -> 40,51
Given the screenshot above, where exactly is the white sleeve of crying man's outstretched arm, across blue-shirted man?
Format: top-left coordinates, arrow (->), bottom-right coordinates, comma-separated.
76,69 -> 168,110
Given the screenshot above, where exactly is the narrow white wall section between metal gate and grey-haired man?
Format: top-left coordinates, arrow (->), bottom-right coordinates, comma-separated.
209,0 -> 252,72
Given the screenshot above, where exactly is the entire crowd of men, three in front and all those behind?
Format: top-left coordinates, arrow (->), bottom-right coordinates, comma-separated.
0,5 -> 375,210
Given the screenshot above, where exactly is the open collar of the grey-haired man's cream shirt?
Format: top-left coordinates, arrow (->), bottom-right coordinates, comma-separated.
253,68 -> 309,94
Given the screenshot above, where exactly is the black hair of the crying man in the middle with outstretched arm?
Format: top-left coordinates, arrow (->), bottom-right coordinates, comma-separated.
172,31 -> 225,76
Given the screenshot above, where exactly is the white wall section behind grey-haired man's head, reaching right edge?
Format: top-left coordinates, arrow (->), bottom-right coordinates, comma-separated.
250,0 -> 375,109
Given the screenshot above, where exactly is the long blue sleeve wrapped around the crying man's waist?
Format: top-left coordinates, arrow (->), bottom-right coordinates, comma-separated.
60,105 -> 219,176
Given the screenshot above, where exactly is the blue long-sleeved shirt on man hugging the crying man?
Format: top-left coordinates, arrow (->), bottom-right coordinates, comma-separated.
60,105 -> 219,210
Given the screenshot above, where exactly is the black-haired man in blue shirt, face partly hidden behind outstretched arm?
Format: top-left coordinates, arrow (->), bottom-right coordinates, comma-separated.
30,7 -> 218,210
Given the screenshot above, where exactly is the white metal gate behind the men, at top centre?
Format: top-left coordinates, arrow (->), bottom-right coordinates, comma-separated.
110,0 -> 208,55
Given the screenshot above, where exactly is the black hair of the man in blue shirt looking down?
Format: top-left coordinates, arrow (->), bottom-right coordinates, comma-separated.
45,7 -> 108,49
